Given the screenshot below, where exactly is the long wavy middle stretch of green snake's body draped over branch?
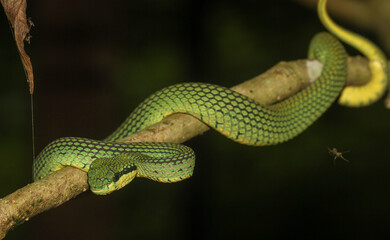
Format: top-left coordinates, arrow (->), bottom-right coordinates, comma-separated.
106,33 -> 347,146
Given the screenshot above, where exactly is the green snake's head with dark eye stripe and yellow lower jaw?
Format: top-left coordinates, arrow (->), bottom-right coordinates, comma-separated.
88,153 -> 138,195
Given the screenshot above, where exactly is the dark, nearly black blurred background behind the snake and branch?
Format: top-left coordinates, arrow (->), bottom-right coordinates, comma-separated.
0,0 -> 390,240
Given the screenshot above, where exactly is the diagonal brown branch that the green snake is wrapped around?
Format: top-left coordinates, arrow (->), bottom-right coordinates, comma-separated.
0,57 -> 384,239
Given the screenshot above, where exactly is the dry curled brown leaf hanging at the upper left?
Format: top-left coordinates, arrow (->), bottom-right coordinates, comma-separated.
0,0 -> 34,94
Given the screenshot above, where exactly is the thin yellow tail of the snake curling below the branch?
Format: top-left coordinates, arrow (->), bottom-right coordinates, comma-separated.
317,0 -> 388,107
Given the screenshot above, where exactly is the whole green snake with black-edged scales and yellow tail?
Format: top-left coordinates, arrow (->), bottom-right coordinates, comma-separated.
33,0 -> 387,194
